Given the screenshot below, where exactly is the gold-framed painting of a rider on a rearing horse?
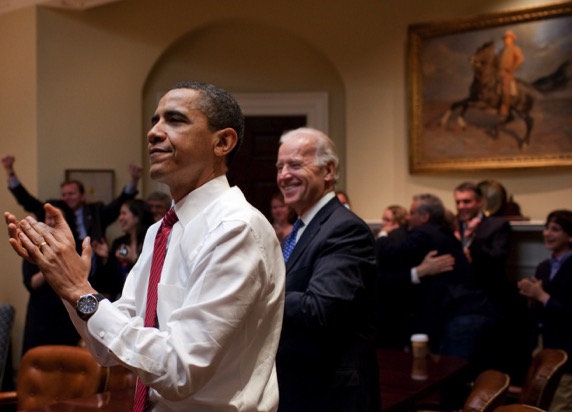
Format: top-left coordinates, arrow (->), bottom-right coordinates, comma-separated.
408,2 -> 572,173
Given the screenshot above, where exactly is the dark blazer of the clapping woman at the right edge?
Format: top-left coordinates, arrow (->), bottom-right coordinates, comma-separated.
534,256 -> 572,373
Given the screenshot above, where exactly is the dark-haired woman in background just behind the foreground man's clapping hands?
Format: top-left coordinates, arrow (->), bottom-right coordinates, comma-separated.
92,199 -> 154,301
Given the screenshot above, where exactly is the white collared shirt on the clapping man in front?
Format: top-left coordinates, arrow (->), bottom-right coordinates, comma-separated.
70,176 -> 285,412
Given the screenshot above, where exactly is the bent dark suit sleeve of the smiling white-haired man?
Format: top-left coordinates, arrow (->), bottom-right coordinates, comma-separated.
284,221 -> 375,333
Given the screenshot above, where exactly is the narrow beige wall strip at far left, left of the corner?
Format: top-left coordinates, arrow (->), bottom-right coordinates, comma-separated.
0,9 -> 38,366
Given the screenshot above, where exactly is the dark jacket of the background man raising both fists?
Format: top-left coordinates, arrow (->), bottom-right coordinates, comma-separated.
10,184 -> 137,240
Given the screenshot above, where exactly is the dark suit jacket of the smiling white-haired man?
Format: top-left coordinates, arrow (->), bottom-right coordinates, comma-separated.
276,197 -> 380,412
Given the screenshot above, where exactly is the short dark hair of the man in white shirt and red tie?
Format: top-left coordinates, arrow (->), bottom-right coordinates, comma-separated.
169,81 -> 244,166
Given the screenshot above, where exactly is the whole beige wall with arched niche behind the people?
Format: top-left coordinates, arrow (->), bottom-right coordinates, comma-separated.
0,0 -> 572,368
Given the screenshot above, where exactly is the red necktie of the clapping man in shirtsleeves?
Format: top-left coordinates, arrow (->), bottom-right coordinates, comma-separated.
133,208 -> 179,412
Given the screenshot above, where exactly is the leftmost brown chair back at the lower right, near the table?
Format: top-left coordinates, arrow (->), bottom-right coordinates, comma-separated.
463,370 -> 510,412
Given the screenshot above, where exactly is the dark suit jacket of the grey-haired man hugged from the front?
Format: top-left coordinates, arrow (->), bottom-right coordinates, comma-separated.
377,223 -> 492,351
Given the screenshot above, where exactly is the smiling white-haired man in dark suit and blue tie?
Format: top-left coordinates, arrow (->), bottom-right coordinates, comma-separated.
276,128 -> 380,412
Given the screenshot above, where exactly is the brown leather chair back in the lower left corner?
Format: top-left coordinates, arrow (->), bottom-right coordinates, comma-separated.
17,345 -> 101,410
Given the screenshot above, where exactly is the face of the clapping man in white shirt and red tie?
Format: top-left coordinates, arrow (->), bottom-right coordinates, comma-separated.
147,88 -> 237,201
